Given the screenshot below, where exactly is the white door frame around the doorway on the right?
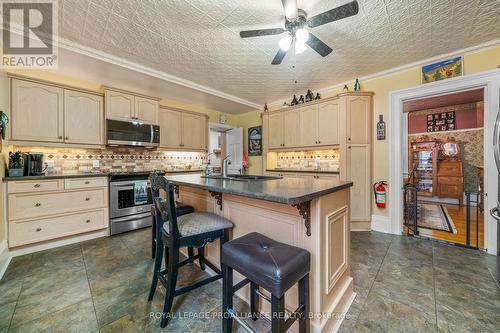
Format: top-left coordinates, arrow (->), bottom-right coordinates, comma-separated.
388,69 -> 500,255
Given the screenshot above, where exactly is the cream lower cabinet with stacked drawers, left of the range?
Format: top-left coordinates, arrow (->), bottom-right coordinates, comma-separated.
7,177 -> 109,247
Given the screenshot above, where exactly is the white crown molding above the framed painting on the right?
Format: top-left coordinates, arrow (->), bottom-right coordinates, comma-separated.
267,39 -> 500,107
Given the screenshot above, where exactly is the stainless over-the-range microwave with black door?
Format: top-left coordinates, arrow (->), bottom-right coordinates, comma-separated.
106,119 -> 160,148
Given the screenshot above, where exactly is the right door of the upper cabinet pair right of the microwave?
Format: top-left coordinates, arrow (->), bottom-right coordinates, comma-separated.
182,113 -> 208,150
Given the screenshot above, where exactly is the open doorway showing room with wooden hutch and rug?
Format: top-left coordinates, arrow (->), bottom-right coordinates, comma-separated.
402,88 -> 484,249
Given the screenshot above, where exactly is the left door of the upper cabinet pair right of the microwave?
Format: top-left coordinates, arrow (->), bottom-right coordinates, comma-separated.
158,109 -> 182,148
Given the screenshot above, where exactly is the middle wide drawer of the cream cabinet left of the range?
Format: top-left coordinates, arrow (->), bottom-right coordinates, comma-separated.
9,188 -> 106,220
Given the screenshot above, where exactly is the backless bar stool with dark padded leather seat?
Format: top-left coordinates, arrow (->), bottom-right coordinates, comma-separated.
221,232 -> 311,333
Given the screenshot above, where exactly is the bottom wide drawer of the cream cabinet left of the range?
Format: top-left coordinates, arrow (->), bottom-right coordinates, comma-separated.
9,209 -> 108,247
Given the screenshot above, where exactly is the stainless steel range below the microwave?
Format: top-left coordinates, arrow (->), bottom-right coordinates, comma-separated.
109,172 -> 165,235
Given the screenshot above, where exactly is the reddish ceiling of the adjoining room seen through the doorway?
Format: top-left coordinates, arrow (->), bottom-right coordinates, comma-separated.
403,88 -> 484,112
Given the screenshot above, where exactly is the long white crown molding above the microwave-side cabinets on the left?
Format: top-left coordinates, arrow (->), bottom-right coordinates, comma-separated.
58,37 -> 260,109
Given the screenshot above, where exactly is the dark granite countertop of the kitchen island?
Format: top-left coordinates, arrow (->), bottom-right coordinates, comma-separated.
165,175 -> 352,205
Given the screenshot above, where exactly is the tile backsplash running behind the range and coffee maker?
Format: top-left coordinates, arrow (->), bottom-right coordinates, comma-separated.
9,146 -> 207,173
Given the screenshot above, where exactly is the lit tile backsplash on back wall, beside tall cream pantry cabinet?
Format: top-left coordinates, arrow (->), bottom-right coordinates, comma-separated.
276,149 -> 340,171
